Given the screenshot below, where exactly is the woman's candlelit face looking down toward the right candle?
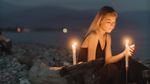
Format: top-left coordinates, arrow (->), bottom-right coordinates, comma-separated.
100,13 -> 117,33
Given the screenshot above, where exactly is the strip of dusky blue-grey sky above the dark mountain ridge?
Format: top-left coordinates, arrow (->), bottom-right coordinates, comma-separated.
1,0 -> 150,11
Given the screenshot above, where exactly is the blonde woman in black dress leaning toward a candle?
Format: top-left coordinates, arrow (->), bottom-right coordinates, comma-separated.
78,6 -> 148,84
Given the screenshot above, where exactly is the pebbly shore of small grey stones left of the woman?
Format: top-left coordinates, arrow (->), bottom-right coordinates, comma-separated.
0,43 -> 150,84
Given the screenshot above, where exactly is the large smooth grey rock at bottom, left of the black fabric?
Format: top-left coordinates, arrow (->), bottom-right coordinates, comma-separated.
29,62 -> 67,84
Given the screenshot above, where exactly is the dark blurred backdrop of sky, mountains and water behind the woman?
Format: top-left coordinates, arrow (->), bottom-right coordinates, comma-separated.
0,0 -> 150,60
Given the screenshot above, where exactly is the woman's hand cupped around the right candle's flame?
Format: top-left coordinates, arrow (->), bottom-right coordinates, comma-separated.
124,44 -> 135,57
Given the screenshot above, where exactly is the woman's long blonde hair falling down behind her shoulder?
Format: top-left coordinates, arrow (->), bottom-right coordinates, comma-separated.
85,6 -> 118,38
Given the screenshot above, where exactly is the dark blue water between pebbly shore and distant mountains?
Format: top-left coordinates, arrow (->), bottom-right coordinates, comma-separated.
3,30 -> 150,60
